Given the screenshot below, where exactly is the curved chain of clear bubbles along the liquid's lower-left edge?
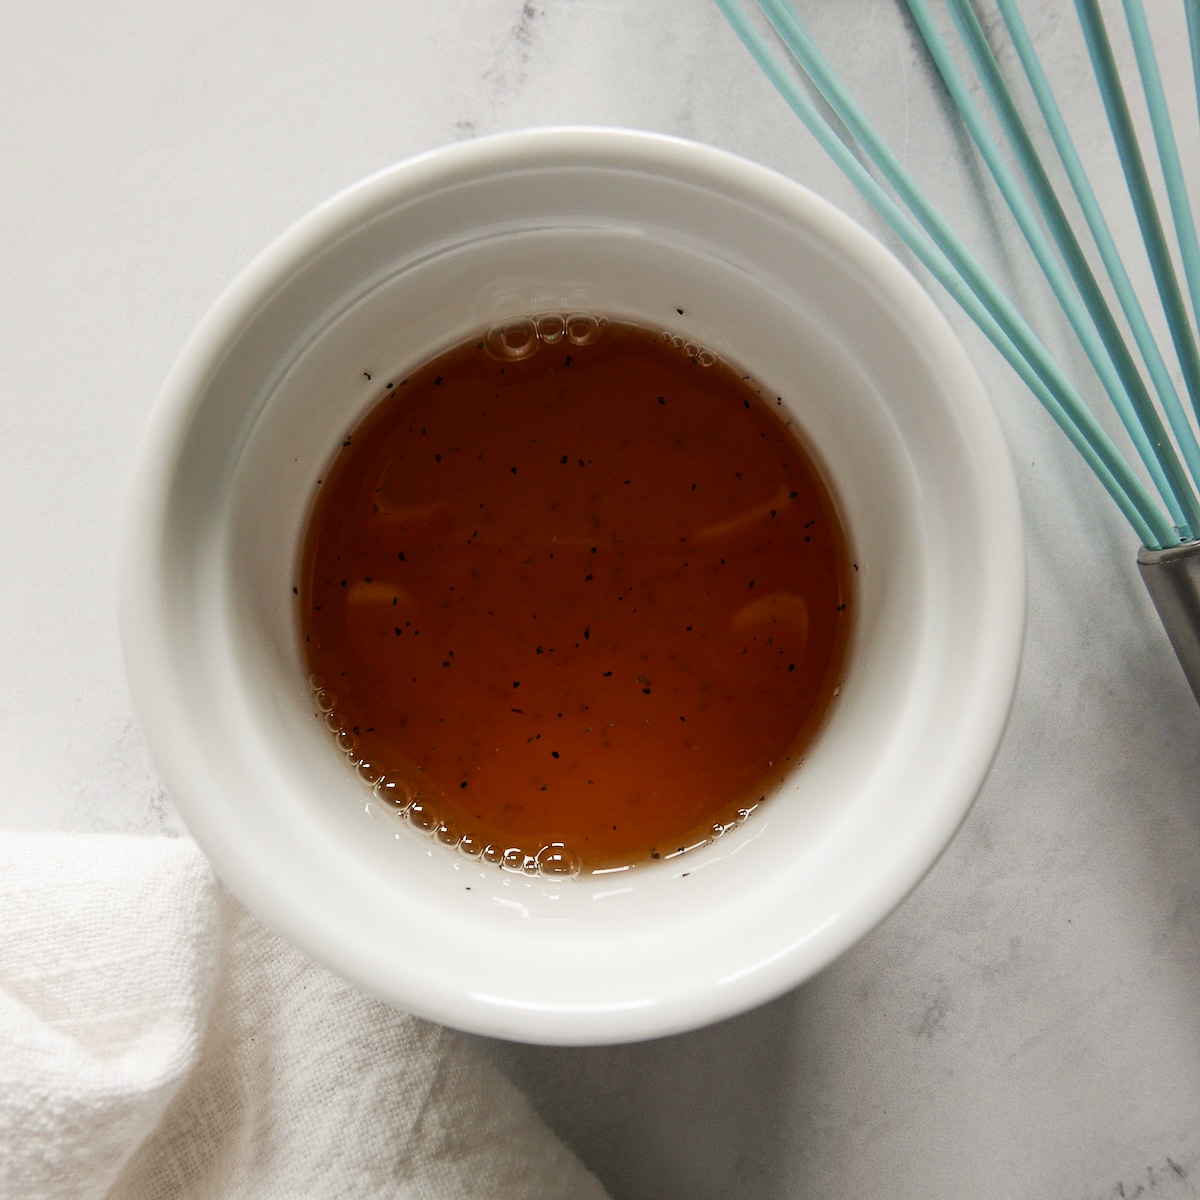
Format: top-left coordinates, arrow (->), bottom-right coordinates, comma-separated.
308,676 -> 581,880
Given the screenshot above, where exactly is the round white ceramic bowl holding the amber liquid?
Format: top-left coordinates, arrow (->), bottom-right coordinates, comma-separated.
121,128 -> 1024,1044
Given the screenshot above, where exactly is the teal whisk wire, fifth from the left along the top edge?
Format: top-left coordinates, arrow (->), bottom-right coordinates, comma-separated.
996,0 -> 1200,501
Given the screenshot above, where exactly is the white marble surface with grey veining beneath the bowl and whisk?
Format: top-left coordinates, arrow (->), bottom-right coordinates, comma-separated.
0,0 -> 1200,1200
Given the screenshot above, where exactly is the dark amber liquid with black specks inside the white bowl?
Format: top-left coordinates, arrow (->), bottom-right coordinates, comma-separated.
299,322 -> 852,872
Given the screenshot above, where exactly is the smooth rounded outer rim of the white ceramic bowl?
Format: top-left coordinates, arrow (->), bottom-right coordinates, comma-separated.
118,126 -> 1025,1044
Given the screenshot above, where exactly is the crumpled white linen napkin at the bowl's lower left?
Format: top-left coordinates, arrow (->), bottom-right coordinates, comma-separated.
0,832 -> 605,1200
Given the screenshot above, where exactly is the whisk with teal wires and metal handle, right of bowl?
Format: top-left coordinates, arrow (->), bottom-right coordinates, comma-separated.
716,0 -> 1200,702
